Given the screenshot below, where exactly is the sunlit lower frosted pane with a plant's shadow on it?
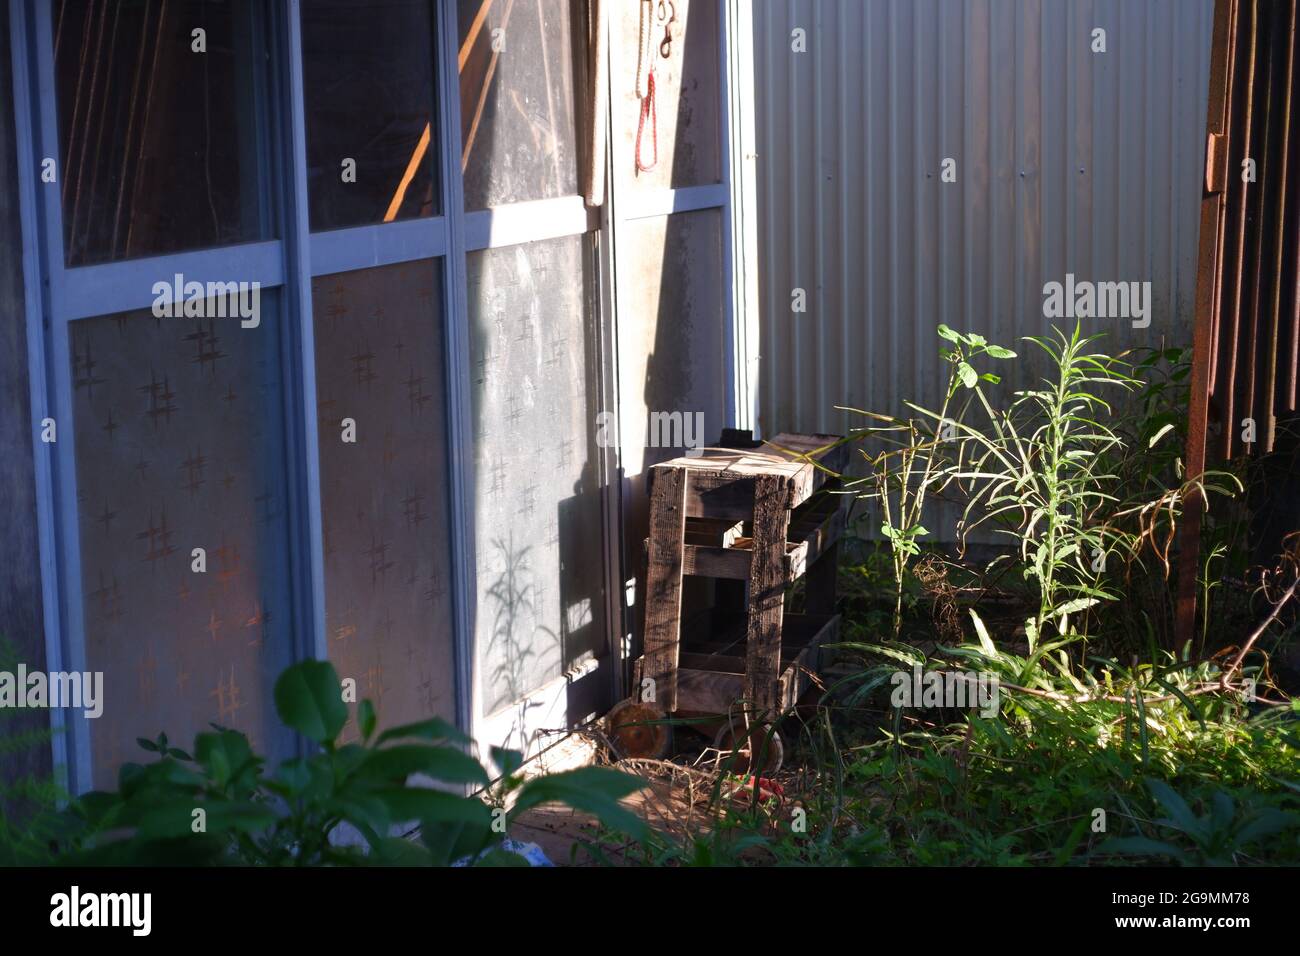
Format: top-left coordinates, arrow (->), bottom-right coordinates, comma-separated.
467,235 -> 606,714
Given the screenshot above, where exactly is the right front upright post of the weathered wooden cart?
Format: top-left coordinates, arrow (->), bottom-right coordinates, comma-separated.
745,475 -> 790,714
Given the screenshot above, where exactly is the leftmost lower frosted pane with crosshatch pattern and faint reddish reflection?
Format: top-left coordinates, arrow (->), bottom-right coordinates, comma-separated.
70,291 -> 293,787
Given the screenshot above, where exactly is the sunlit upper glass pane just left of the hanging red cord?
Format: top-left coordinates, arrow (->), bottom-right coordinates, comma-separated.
458,0 -> 580,209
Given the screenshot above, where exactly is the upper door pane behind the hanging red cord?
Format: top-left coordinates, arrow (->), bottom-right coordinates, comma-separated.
614,0 -> 722,189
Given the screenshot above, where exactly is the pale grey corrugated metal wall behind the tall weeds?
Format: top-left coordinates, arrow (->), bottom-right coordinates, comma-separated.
754,0 -> 1213,450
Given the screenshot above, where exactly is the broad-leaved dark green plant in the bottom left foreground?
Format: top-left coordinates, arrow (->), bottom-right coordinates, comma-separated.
54,661 -> 647,866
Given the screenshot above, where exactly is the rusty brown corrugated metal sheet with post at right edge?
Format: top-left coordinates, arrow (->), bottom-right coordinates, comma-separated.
1175,0 -> 1300,645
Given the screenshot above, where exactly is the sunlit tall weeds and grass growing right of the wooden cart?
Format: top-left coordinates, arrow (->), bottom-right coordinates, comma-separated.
579,321 -> 1300,865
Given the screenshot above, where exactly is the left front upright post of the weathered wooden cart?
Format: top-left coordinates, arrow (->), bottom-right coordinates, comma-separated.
641,468 -> 689,713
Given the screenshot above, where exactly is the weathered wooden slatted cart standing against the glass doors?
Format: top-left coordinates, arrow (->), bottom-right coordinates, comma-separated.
636,434 -> 846,715
